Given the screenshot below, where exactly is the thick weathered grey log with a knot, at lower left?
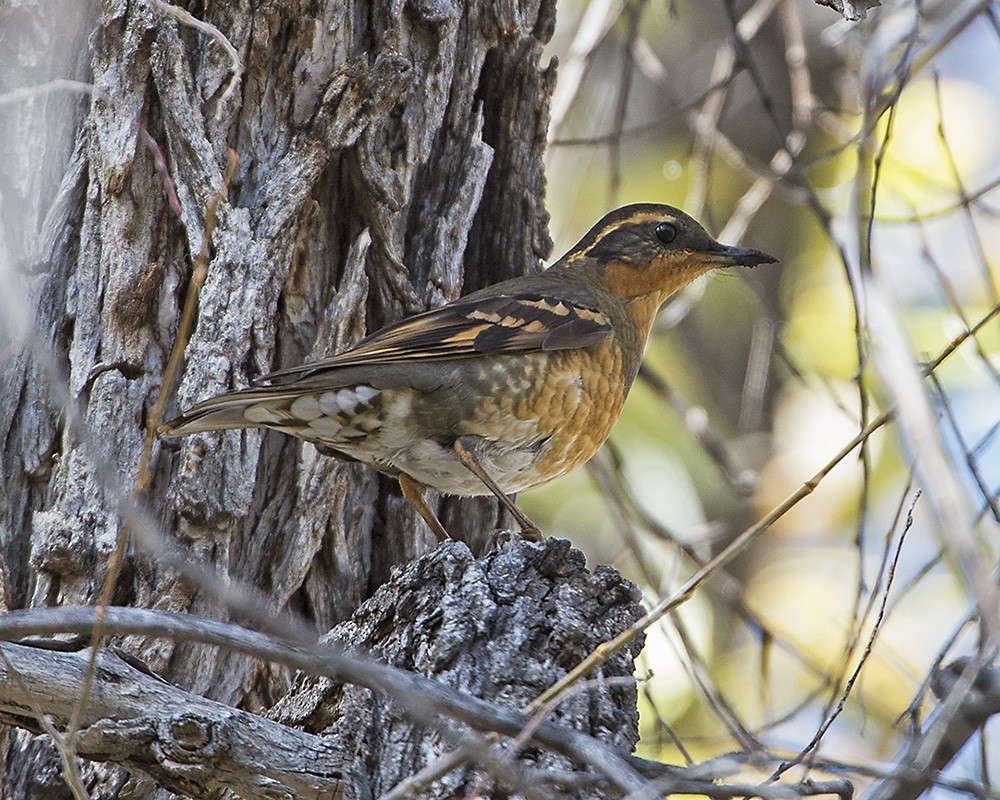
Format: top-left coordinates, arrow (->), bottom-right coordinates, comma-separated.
0,640 -> 365,798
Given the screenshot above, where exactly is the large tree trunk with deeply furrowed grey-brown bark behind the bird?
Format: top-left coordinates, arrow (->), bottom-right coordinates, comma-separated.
0,0 -> 648,797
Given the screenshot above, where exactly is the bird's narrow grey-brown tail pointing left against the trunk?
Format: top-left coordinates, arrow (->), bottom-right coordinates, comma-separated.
156,386 -> 298,438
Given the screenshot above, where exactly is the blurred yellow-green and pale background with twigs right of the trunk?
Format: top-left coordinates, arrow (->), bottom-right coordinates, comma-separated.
521,0 -> 1000,796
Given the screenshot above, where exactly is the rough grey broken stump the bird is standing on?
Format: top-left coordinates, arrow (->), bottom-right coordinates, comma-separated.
271,537 -> 642,798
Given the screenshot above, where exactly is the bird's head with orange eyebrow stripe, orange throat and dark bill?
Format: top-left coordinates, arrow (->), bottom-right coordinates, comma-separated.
556,203 -> 777,305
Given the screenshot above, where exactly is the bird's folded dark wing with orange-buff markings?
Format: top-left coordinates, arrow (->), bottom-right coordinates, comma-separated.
261,293 -> 611,383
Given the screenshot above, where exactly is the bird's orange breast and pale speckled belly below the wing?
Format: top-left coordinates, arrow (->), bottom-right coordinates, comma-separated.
262,342 -> 631,495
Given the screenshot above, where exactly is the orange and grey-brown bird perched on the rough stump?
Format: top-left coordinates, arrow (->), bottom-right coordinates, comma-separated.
159,203 -> 777,540
